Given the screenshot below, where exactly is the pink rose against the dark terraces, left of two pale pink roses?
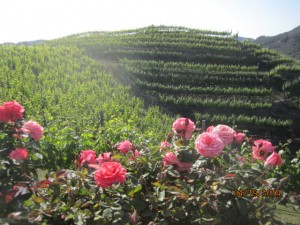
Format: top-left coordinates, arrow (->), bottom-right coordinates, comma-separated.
172,118 -> 196,139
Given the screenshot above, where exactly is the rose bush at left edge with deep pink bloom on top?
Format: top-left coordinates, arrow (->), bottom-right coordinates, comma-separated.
0,101 -> 43,221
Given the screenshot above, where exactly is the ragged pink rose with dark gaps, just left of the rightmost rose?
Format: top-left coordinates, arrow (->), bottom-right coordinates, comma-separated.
252,139 -> 274,161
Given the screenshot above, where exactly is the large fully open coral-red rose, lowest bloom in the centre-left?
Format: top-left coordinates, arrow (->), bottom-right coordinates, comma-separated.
94,162 -> 126,188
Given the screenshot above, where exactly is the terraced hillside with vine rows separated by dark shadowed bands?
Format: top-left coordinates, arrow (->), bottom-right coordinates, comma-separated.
51,26 -> 300,144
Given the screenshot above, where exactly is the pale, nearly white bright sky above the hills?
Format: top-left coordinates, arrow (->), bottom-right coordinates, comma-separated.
0,0 -> 300,43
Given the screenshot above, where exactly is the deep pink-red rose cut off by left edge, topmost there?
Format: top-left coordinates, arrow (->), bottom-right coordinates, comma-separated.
0,101 -> 25,123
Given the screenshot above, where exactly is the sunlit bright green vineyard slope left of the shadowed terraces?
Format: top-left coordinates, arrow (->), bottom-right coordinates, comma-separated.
0,45 -> 174,169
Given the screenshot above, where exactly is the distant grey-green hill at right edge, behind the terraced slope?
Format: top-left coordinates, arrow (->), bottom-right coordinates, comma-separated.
254,26 -> 300,60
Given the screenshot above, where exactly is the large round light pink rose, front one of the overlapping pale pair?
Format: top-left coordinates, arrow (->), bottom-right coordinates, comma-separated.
195,132 -> 224,157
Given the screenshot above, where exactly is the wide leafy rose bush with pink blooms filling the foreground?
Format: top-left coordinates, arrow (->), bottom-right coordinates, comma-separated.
0,102 -> 299,224
